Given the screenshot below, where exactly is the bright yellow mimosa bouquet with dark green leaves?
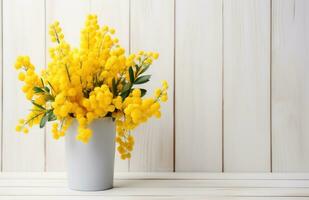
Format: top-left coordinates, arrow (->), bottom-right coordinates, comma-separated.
15,15 -> 168,159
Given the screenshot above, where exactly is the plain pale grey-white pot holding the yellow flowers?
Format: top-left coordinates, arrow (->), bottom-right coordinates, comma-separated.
65,117 -> 115,191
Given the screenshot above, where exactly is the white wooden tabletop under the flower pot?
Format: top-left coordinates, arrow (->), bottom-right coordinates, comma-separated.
0,173 -> 309,200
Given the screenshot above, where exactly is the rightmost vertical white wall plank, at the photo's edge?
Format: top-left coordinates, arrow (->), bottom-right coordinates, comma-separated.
272,0 -> 309,172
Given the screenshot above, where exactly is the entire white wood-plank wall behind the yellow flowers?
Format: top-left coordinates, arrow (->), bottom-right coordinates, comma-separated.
0,0 -> 309,172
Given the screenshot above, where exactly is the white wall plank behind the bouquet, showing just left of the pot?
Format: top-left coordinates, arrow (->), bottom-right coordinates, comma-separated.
46,0 -> 90,171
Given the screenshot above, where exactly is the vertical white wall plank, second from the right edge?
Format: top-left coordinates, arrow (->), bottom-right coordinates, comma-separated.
223,0 -> 270,172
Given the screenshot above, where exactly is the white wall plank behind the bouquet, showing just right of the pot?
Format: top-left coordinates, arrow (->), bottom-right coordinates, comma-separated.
90,0 -> 130,171
